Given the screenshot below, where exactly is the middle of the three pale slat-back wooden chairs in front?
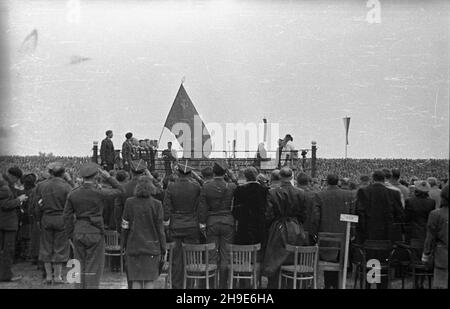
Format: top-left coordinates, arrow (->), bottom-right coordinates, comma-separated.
227,244 -> 261,289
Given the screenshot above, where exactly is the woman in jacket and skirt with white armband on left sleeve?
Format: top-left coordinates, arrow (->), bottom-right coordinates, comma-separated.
122,177 -> 166,289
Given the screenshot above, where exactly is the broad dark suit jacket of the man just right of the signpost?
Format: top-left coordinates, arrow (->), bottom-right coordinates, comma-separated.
356,183 -> 404,242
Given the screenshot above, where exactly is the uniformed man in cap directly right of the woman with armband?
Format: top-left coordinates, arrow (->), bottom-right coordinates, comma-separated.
163,162 -> 201,289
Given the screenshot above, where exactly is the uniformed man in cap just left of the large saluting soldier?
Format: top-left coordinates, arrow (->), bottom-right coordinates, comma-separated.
36,162 -> 72,284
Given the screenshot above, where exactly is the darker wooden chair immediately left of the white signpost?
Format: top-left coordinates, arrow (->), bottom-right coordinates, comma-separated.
318,233 -> 345,289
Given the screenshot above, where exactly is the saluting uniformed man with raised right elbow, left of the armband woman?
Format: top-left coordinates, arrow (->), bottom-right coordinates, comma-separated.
64,163 -> 122,289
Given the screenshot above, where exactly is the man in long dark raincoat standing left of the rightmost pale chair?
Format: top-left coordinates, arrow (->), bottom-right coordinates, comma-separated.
263,167 -> 307,288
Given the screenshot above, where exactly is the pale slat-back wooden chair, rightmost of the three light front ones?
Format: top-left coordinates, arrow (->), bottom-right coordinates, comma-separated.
278,245 -> 319,289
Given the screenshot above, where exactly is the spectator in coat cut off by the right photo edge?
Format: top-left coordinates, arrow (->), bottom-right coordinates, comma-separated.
422,185 -> 449,289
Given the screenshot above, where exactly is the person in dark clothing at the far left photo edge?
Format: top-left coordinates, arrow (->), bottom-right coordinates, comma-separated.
0,167 -> 28,282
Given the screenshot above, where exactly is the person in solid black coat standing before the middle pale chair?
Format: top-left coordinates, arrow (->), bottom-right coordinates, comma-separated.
233,167 -> 268,248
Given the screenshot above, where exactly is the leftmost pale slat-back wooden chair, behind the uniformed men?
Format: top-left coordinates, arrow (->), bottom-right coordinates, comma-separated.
181,243 -> 218,289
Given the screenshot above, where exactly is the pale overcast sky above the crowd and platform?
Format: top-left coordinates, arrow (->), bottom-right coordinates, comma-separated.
0,0 -> 449,158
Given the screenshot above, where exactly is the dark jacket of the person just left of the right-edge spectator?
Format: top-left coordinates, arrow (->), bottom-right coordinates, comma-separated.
405,196 -> 436,240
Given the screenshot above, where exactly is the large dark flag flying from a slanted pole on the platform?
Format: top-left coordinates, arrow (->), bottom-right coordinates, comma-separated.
164,84 -> 211,158
